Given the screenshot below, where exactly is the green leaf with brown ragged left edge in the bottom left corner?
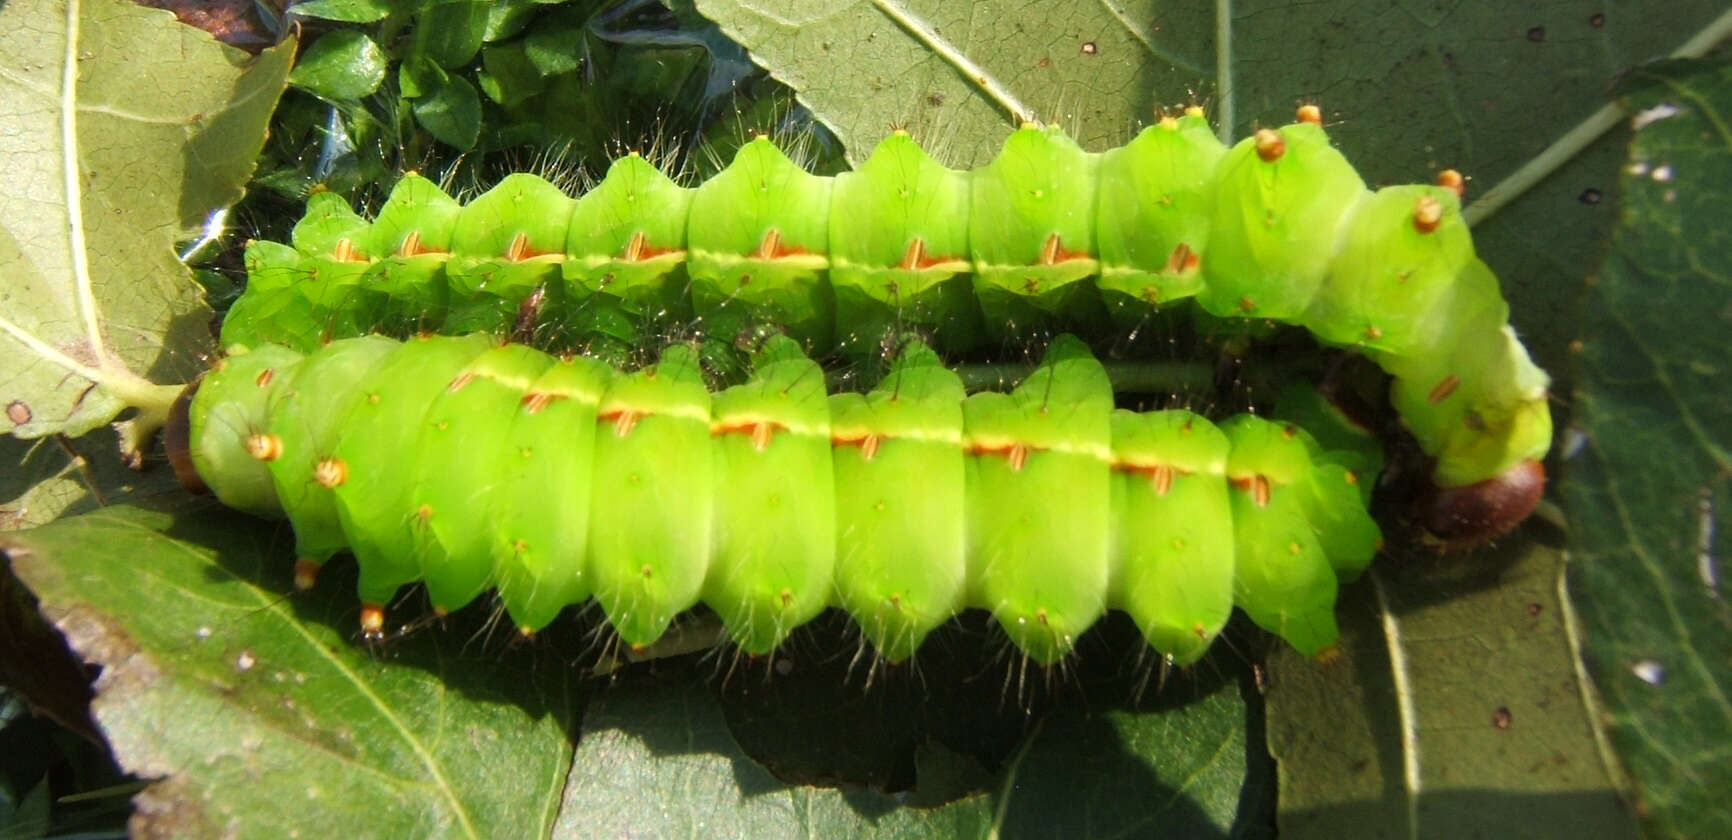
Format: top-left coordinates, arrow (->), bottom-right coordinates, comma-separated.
0,507 -> 577,837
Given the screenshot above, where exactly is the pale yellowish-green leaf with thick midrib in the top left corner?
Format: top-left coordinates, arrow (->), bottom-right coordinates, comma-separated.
0,0 -> 294,452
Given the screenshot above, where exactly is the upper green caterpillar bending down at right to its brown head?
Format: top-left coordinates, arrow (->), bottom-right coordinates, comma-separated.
222,106 -> 1552,542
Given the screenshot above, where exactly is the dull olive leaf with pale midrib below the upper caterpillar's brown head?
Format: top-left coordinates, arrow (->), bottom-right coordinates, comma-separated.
1268,540 -> 1640,840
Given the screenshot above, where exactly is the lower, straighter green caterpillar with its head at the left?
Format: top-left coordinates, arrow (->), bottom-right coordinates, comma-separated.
178,334 -> 1380,663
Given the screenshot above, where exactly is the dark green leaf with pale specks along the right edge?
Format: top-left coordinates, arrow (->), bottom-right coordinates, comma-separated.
1566,62 -> 1732,837
